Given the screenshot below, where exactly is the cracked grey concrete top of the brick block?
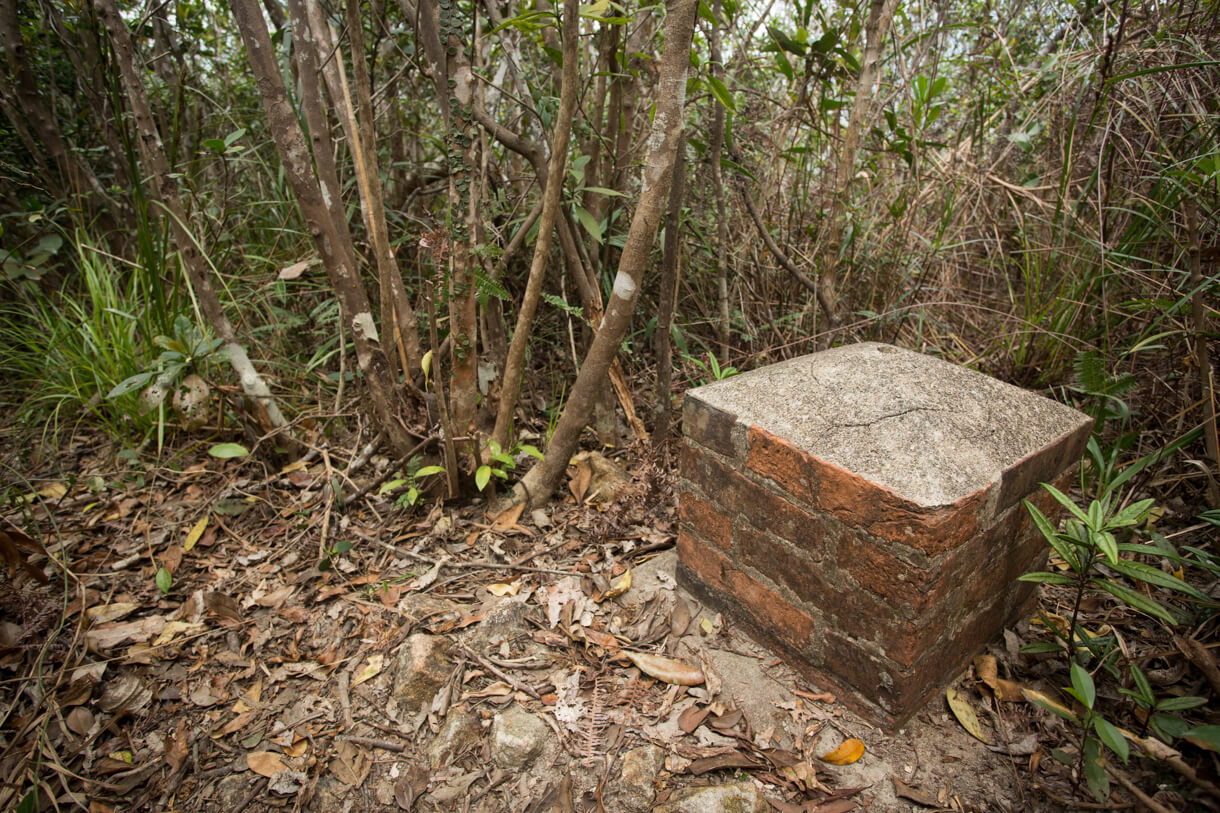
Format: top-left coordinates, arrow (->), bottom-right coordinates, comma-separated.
687,342 -> 1091,507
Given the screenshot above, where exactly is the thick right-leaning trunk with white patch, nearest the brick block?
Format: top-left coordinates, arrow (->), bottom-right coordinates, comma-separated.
517,0 -> 699,505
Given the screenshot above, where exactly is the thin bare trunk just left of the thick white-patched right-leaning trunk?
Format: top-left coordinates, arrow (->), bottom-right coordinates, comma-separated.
492,0 -> 581,448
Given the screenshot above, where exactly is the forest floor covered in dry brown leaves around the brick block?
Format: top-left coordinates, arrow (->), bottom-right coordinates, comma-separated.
0,427 -> 1216,813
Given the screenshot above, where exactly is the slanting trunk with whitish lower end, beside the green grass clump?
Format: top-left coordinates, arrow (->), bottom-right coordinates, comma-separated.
95,0 -> 288,431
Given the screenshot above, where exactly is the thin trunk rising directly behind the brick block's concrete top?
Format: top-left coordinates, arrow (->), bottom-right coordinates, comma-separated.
817,0 -> 898,348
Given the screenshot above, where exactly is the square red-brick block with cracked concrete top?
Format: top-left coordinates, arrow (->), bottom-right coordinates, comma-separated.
678,343 -> 1092,728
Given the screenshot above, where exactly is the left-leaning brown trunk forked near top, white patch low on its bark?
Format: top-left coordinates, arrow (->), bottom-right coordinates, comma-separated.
230,0 -> 415,455
